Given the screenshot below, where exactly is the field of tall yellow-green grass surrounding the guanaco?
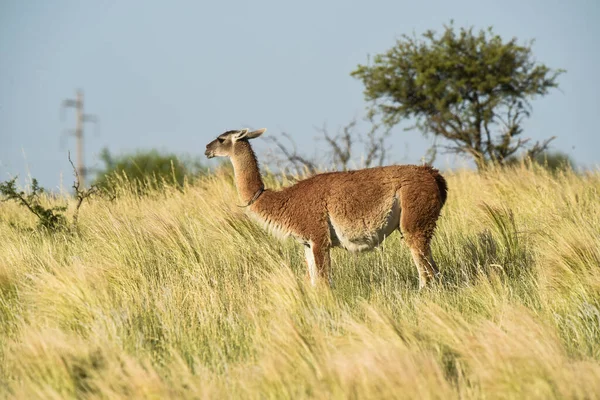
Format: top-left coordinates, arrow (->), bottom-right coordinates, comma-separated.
0,167 -> 600,399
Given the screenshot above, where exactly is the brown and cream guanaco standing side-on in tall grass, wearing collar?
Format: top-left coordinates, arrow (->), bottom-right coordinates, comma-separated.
206,130 -> 447,287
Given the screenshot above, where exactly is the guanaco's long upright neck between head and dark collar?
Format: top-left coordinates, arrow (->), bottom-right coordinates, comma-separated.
231,141 -> 264,205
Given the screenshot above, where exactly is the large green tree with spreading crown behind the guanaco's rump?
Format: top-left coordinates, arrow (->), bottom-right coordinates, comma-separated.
351,23 -> 564,169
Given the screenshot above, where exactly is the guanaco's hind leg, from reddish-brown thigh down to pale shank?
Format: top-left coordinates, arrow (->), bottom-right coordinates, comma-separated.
400,185 -> 442,289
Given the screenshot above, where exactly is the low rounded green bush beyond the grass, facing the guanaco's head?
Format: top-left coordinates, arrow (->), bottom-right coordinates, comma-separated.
94,148 -> 203,191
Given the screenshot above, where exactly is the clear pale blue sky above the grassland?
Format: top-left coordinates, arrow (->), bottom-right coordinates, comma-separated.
0,0 -> 600,189
